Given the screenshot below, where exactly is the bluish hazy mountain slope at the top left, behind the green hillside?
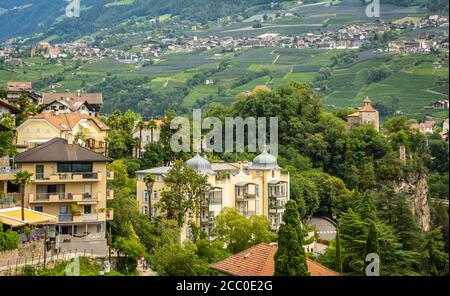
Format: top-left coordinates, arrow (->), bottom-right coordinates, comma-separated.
0,0 -> 281,41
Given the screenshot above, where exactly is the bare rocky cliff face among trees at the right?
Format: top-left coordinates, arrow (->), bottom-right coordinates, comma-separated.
395,174 -> 430,231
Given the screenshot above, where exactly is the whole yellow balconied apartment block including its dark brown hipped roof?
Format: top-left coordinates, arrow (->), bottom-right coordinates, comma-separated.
14,138 -> 114,238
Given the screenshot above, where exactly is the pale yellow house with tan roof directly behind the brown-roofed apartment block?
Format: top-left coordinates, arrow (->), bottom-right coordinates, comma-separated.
16,112 -> 109,155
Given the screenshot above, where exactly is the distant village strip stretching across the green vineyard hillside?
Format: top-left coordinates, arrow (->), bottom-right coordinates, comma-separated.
0,15 -> 449,64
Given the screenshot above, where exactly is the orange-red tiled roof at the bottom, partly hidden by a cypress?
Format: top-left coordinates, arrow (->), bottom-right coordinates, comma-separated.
211,243 -> 339,276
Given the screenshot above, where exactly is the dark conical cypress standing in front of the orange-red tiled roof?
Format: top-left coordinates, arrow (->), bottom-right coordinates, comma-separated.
275,200 -> 309,276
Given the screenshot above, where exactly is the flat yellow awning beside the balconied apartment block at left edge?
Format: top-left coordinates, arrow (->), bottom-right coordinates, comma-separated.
0,207 -> 57,227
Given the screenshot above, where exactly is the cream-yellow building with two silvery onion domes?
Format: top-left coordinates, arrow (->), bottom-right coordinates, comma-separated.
136,150 -> 289,239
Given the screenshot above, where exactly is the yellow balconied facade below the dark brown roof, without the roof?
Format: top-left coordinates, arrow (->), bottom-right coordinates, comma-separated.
18,162 -> 114,235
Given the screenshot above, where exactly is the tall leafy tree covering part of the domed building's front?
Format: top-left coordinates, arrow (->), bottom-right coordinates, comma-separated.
159,160 -> 208,227
